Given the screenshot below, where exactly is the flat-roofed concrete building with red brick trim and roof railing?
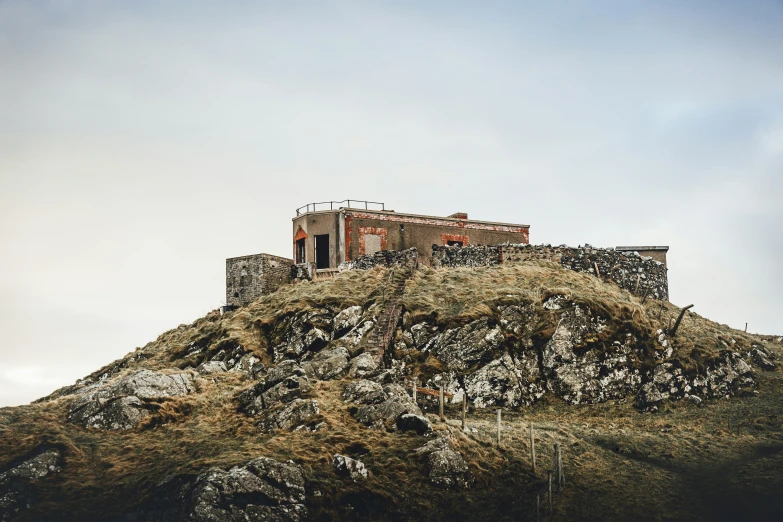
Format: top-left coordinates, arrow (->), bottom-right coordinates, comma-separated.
293,200 -> 530,270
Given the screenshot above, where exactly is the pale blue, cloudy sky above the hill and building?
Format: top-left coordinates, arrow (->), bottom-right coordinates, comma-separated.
0,0 -> 783,406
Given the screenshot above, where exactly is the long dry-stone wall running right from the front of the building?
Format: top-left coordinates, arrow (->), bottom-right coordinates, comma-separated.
432,244 -> 669,300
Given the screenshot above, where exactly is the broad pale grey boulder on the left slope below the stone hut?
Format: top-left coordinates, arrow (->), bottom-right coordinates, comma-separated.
67,370 -> 195,430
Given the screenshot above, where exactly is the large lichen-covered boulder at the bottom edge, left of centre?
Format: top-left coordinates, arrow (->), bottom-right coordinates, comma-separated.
149,457 -> 308,522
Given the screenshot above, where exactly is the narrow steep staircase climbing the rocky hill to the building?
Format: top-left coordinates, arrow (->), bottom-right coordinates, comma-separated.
365,258 -> 419,367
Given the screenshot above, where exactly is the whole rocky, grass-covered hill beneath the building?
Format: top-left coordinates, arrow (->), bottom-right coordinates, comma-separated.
0,261 -> 783,521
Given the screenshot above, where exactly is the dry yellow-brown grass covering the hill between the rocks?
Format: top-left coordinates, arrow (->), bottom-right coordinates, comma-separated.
0,263 -> 783,520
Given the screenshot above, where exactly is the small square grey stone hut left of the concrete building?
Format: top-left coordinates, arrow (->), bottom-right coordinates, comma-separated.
226,254 -> 294,307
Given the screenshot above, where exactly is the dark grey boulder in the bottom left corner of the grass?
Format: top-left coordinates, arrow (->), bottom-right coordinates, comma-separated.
0,449 -> 62,522
